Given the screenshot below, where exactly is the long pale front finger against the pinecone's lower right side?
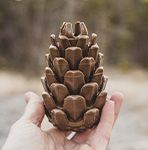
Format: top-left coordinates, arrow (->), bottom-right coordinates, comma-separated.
91,101 -> 114,150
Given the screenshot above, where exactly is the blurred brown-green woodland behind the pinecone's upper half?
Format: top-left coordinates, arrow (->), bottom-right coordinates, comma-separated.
0,0 -> 148,73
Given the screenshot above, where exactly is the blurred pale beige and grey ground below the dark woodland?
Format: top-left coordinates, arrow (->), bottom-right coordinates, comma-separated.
0,69 -> 148,150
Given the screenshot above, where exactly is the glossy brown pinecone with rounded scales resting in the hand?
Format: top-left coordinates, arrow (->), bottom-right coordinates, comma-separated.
41,21 -> 108,131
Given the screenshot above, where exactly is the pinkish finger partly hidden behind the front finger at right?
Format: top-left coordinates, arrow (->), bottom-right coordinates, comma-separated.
110,92 -> 123,123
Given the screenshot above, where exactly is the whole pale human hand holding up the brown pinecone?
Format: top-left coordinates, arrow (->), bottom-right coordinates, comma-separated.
2,92 -> 123,150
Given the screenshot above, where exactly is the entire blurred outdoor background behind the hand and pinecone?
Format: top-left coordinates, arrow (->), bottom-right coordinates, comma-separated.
0,0 -> 148,150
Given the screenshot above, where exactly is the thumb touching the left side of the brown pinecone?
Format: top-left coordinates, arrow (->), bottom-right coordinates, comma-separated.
23,92 -> 45,126
